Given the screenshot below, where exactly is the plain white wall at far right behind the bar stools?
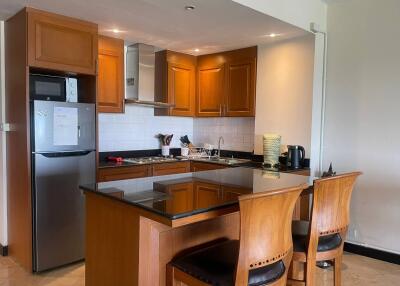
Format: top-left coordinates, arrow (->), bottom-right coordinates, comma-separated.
324,0 -> 400,253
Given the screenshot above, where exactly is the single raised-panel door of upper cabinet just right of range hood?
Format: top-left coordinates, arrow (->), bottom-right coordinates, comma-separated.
168,63 -> 195,116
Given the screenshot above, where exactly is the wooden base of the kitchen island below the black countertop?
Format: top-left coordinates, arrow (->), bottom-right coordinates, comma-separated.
85,192 -> 239,286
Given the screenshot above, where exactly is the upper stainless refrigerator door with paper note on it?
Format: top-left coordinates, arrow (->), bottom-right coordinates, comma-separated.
31,100 -> 96,153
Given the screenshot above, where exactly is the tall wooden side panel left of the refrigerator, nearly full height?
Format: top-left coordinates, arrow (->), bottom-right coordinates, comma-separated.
5,9 -> 32,272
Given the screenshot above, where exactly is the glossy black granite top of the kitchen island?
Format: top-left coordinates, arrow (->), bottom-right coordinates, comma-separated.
81,167 -> 312,220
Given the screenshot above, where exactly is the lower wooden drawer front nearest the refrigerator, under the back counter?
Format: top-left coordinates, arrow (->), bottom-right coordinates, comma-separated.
98,165 -> 152,182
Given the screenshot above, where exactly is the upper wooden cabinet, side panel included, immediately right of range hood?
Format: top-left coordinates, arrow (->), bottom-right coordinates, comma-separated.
154,51 -> 196,116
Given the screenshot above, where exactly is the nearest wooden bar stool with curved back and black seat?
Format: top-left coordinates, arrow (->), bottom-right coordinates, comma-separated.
167,185 -> 307,286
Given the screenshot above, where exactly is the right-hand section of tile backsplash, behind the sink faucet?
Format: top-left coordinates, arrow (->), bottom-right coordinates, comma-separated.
193,117 -> 255,152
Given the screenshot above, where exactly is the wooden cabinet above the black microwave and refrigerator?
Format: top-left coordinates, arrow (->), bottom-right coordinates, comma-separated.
26,8 -> 97,75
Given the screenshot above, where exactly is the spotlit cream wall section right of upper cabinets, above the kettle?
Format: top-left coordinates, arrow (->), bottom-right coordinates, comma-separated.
255,34 -> 315,157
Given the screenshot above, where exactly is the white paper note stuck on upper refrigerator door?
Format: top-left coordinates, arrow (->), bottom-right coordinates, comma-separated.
53,107 -> 78,146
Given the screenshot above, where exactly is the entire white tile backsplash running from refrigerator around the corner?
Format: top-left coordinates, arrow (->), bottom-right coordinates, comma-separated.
99,105 -> 254,152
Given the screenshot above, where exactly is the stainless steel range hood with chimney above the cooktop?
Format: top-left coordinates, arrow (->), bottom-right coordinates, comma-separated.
125,43 -> 173,108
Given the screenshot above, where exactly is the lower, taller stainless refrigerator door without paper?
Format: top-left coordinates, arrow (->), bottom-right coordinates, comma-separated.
32,151 -> 96,271
